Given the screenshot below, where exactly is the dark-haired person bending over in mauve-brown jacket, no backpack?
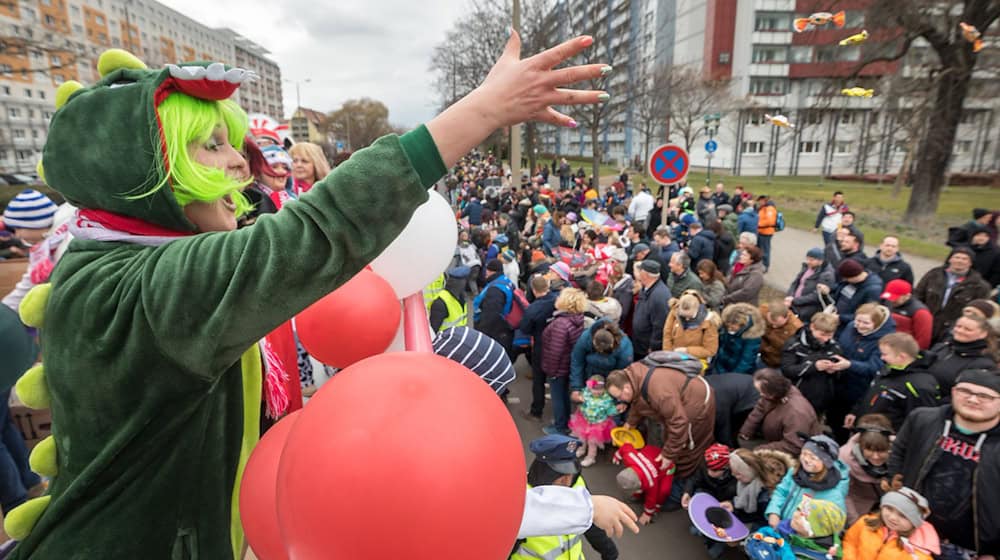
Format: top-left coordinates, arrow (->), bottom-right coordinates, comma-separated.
740,368 -> 821,456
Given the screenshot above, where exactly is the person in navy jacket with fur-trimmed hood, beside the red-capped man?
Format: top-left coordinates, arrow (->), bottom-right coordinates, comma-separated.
828,303 -> 896,441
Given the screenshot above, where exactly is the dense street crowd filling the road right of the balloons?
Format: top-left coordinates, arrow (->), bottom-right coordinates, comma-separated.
431,152 -> 1000,560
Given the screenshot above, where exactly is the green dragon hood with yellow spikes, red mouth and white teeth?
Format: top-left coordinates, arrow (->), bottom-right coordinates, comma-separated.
39,49 -> 255,232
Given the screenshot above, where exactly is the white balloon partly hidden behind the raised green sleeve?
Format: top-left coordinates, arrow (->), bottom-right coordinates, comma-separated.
371,190 -> 458,299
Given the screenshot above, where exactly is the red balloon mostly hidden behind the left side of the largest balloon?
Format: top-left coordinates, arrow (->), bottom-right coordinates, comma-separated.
240,409 -> 302,560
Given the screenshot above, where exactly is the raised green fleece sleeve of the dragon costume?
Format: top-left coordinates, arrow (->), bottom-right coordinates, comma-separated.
137,127 -> 446,377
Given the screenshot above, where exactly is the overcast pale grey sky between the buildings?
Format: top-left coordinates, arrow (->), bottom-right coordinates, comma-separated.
159,0 -> 467,126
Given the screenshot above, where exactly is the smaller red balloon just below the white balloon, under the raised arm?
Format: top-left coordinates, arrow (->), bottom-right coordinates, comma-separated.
295,269 -> 402,368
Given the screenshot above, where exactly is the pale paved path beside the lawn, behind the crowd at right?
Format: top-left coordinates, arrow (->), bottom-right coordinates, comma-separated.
764,228 -> 943,293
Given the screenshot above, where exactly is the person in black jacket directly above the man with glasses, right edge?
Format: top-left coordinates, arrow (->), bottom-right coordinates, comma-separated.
927,312 -> 997,394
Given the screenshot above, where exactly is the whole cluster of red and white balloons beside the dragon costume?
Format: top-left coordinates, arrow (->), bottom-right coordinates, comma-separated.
240,192 -> 525,560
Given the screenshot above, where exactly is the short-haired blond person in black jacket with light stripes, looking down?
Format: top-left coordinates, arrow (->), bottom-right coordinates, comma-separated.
844,332 -> 941,430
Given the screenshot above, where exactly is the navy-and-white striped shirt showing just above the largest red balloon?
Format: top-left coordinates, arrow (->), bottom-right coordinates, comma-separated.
434,327 -> 516,394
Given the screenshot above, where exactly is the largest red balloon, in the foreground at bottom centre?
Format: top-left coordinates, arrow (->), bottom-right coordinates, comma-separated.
278,352 -> 526,560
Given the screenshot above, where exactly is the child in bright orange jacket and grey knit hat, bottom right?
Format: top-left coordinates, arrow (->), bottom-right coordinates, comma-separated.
844,487 -> 941,560
